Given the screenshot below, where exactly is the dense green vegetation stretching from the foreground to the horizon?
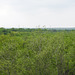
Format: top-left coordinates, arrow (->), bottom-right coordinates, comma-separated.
0,28 -> 75,75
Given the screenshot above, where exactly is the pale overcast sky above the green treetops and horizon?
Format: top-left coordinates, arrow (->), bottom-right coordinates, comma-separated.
0,0 -> 75,28
